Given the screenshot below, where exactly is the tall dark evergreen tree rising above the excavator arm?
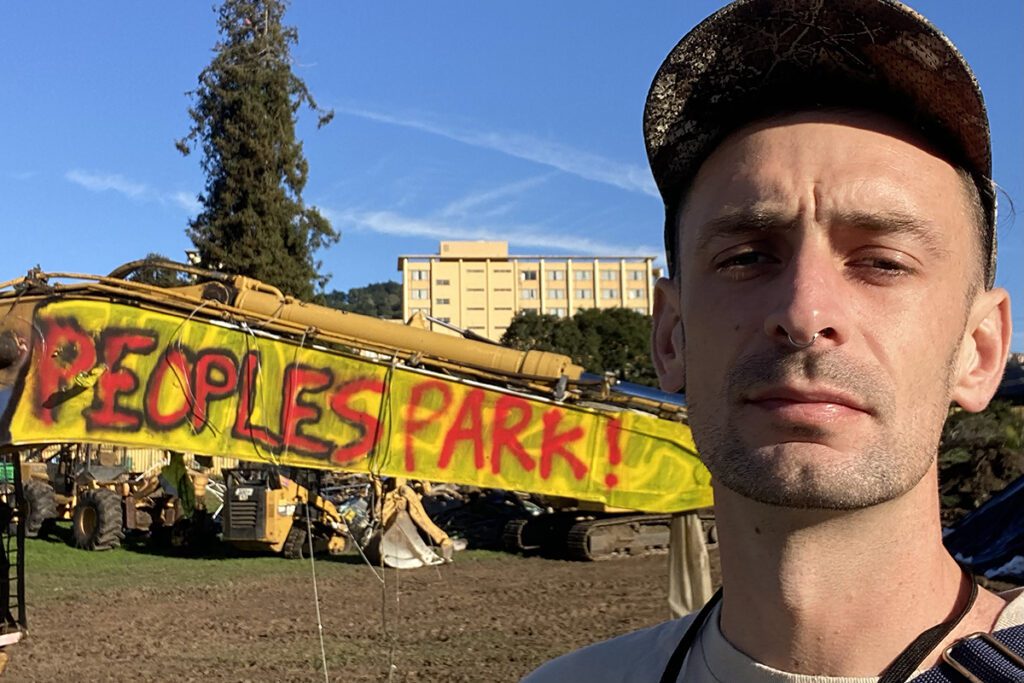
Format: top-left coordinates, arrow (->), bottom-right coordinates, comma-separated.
176,0 -> 338,299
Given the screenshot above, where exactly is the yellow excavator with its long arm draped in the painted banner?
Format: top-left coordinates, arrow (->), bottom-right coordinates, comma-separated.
0,259 -> 712,663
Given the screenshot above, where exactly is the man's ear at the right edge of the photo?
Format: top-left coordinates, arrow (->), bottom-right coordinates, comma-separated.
952,288 -> 1013,413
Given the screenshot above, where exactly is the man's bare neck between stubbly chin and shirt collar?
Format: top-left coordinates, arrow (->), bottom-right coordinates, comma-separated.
715,468 -> 1004,676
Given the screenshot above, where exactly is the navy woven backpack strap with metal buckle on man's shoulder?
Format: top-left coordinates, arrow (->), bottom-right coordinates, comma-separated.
912,625 -> 1024,683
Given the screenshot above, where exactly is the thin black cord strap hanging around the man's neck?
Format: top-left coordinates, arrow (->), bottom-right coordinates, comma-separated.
660,569 -> 978,683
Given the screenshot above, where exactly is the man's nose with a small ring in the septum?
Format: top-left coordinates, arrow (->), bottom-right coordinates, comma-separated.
764,239 -> 850,348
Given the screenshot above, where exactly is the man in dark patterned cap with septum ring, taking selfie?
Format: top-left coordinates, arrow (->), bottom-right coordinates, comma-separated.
526,0 -> 1024,683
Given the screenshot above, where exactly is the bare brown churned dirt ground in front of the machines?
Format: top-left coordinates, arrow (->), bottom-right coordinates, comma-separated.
4,547 -> 717,683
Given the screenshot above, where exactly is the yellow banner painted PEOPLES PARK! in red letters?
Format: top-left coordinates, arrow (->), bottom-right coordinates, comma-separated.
4,300 -> 711,512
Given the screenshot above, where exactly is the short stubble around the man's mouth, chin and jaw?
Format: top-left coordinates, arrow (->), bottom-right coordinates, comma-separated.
688,349 -> 955,510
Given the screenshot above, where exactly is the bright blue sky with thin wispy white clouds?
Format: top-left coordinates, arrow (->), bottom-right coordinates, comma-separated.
0,0 -> 1024,351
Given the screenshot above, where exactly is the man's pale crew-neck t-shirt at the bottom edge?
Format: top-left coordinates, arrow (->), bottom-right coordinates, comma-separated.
522,591 -> 1024,683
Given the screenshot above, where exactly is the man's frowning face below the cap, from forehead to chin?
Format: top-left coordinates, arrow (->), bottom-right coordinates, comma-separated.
663,113 -> 979,509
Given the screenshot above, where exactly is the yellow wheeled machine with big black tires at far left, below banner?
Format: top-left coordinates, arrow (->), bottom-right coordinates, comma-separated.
20,443 -> 206,550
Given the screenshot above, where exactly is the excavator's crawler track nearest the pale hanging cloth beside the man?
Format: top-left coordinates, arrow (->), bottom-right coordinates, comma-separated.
565,515 -> 672,561
